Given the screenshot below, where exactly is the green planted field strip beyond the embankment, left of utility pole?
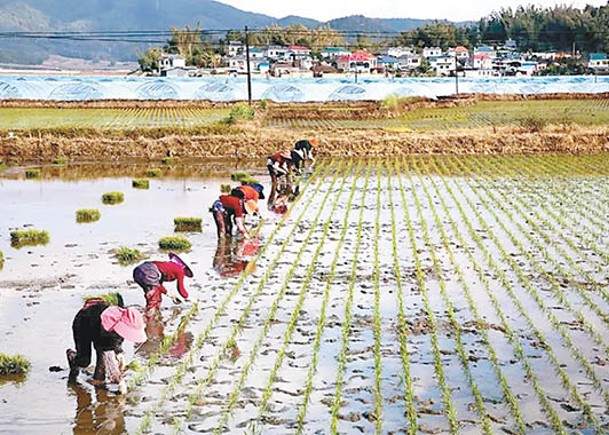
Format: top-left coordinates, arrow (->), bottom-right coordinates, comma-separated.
0,107 -> 229,130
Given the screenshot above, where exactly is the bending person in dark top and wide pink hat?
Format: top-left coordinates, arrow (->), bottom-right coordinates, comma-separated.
66,298 -> 146,393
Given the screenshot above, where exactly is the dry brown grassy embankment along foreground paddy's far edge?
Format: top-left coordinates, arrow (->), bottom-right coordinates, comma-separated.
0,126 -> 609,163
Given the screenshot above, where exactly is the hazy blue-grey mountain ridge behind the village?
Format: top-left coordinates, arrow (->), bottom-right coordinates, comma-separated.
0,0 -> 458,64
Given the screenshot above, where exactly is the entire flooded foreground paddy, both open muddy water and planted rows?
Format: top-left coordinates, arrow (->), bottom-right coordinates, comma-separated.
0,154 -> 609,434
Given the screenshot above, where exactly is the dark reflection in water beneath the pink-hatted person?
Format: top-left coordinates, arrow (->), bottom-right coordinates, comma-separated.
68,383 -> 126,435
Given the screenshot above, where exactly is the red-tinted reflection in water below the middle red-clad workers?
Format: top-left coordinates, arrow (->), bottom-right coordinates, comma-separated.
214,237 -> 260,277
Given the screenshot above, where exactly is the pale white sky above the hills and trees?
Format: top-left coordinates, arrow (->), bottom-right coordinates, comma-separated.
218,0 -> 607,21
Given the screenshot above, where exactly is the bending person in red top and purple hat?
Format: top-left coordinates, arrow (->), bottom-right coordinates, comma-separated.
133,252 -> 194,310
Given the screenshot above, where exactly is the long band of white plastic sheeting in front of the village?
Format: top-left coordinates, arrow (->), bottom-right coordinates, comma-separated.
0,76 -> 609,102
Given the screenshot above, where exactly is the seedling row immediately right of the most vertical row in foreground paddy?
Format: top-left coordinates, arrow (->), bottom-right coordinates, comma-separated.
387,165 -> 418,435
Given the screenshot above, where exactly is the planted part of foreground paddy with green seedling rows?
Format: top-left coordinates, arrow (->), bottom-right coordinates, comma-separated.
128,154 -> 609,434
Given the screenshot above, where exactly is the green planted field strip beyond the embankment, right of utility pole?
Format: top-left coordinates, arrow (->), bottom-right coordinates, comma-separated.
267,100 -> 609,131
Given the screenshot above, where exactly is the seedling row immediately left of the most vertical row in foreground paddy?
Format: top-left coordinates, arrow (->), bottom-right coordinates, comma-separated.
330,162 -> 371,434
